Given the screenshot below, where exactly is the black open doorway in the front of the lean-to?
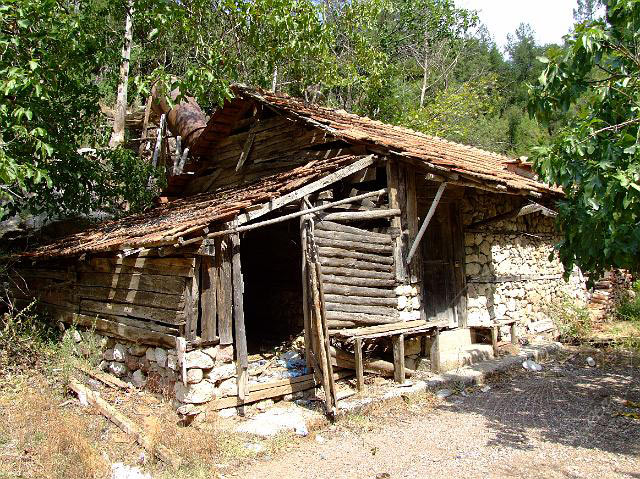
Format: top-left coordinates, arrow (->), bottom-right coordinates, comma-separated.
241,220 -> 304,354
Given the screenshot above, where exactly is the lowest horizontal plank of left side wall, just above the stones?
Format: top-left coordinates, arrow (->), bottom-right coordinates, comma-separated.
56,313 -> 176,348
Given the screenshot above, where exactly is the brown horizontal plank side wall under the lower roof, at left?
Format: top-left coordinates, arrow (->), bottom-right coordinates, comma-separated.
9,250 -> 200,346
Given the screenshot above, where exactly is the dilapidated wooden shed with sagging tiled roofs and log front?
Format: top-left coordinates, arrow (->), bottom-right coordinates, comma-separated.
12,86 -> 584,416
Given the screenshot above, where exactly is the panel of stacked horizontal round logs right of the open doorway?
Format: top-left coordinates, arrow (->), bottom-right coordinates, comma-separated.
314,217 -> 399,329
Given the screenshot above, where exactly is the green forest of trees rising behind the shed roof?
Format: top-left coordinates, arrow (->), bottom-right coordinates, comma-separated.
0,0 -> 580,221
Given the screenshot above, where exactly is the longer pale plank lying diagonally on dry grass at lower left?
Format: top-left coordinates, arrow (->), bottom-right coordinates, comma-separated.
69,379 -> 181,469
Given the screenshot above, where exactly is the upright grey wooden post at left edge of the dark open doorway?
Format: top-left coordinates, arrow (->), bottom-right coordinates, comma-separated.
231,233 -> 249,399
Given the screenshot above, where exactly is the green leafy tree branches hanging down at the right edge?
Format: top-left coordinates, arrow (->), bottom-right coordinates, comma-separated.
530,0 -> 640,280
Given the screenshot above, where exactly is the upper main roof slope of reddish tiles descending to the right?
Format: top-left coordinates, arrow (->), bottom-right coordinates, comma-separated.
219,86 -> 560,194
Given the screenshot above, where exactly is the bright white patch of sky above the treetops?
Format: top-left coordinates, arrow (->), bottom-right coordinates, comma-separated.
456,0 -> 577,47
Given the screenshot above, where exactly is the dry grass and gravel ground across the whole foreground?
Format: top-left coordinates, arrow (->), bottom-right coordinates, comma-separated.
0,353 -> 640,479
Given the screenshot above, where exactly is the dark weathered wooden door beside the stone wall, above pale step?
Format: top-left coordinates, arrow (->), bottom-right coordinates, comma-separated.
421,201 -> 466,326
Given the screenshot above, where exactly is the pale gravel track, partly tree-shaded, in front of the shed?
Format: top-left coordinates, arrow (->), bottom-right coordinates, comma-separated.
232,355 -> 640,479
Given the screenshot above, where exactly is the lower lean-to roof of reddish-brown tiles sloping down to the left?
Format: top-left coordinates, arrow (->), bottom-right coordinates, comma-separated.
22,155 -> 361,258
